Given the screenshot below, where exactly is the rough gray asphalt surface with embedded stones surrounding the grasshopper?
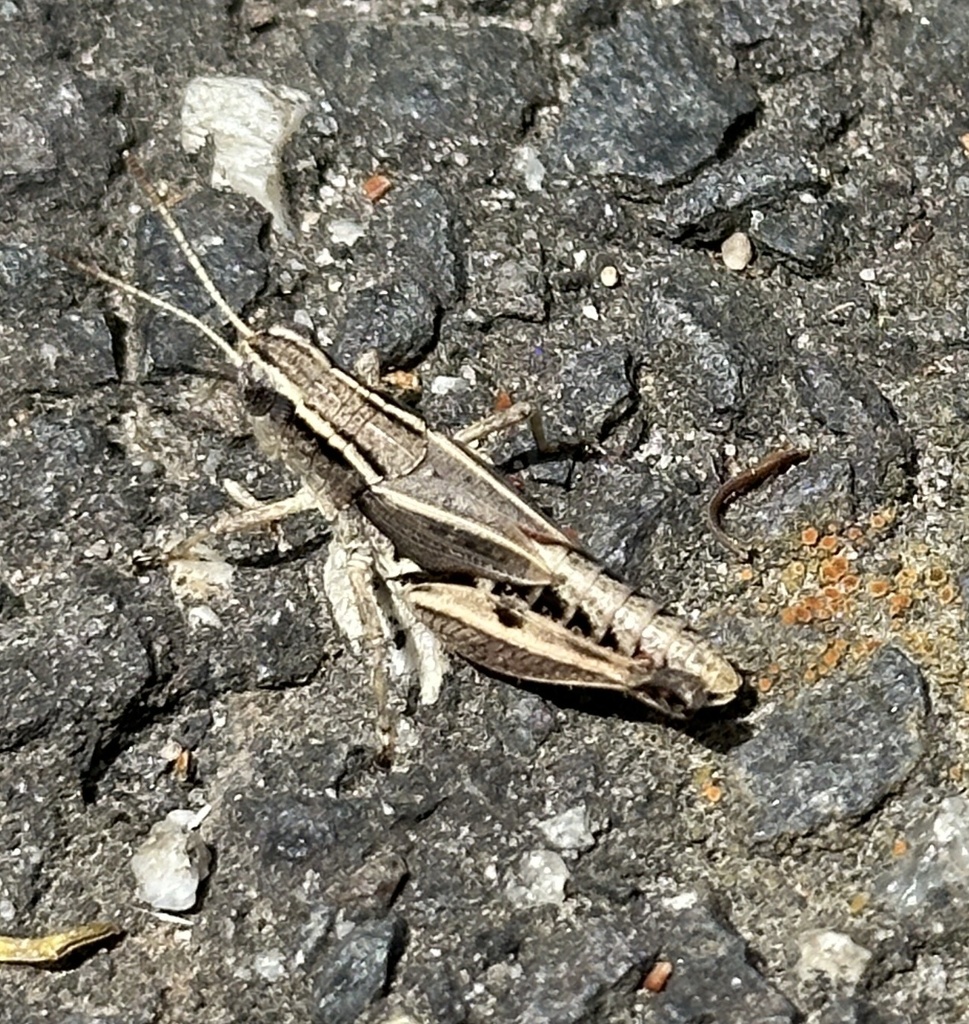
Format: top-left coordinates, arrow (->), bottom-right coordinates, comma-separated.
0,0 -> 969,1024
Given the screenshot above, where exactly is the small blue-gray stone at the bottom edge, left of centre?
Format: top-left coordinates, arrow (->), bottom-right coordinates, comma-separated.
310,916 -> 407,1024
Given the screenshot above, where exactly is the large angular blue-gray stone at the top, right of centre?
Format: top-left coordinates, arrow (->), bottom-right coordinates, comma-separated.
547,7 -> 758,187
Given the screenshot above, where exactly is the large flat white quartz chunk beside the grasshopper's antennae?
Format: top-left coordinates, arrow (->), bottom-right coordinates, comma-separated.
181,76 -> 309,233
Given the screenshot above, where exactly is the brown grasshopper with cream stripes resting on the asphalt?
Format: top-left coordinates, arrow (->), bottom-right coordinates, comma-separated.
70,153 -> 741,729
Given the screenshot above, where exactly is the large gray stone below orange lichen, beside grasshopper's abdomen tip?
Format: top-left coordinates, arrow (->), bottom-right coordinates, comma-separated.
733,647 -> 928,840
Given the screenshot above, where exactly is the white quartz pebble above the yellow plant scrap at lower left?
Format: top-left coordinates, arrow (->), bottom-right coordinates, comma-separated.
131,808 -> 212,910
